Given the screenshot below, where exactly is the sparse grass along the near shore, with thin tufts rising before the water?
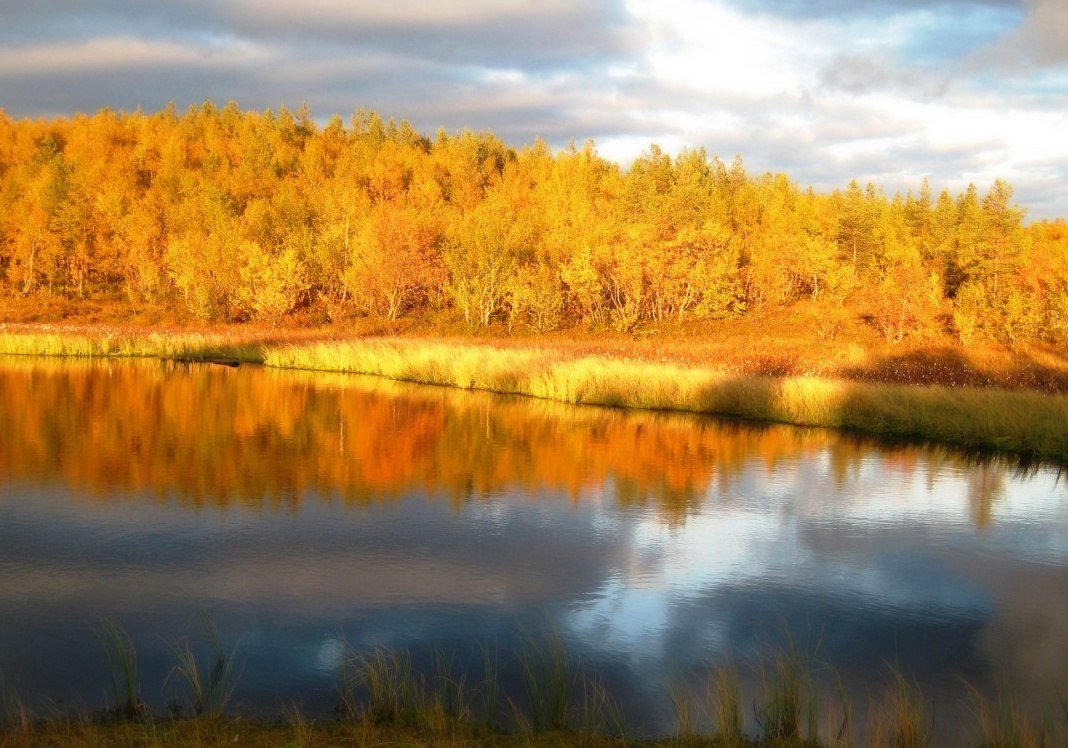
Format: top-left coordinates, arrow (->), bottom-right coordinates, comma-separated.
0,619 -> 1068,748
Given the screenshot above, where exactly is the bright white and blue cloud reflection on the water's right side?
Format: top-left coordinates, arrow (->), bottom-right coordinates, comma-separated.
569,446 -> 1068,726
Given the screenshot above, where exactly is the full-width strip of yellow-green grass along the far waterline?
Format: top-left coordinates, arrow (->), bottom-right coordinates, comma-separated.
0,327 -> 1068,463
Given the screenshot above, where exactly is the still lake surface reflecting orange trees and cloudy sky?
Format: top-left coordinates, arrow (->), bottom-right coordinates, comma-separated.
0,357 -> 1068,735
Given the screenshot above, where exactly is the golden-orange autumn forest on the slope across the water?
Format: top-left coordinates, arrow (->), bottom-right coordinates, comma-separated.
0,103 -> 1068,347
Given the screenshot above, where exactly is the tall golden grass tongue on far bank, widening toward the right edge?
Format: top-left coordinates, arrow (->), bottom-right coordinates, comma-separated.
264,339 -> 1068,462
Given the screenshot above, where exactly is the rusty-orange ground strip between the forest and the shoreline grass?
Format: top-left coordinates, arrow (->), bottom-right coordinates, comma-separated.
0,298 -> 1068,393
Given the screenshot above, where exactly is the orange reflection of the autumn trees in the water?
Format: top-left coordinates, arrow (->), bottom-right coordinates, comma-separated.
0,360 -> 1016,524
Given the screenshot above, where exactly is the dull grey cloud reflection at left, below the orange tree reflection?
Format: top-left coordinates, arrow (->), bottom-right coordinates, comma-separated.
0,492 -> 619,617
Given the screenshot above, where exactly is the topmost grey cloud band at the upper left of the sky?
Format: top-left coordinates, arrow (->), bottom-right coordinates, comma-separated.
0,0 -> 640,69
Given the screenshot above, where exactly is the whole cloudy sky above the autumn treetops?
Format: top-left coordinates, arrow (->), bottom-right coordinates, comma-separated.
0,0 -> 1068,219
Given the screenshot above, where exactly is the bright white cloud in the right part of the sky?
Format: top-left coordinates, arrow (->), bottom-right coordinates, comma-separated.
599,0 -> 1068,216
